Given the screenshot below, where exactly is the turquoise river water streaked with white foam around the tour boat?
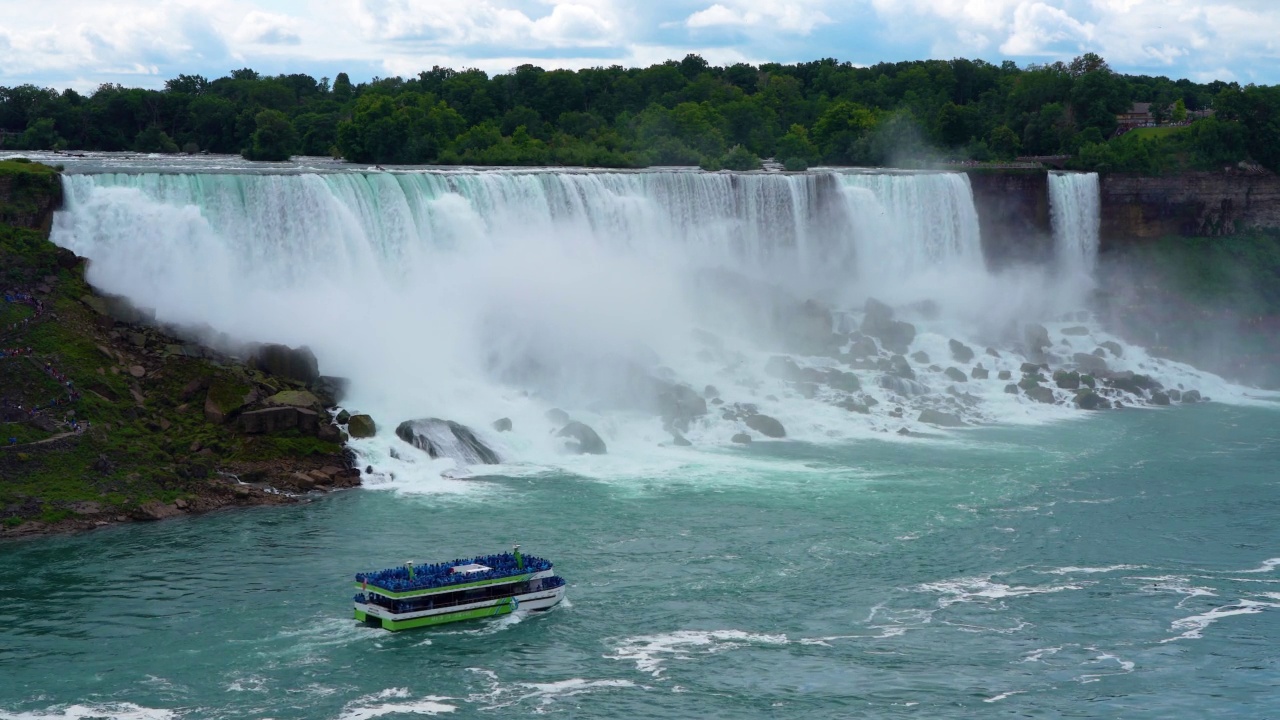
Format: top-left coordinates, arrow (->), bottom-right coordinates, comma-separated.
0,404 -> 1280,720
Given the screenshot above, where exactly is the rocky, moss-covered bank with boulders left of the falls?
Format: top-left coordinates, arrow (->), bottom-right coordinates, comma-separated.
0,161 -> 360,538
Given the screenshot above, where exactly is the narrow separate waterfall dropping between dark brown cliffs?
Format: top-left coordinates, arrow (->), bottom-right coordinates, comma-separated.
1048,173 -> 1102,277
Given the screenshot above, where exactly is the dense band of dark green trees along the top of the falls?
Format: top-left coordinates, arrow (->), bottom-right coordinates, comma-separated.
0,54 -> 1280,173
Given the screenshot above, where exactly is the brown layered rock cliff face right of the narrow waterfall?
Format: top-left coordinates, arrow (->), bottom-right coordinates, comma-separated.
1101,172 -> 1280,245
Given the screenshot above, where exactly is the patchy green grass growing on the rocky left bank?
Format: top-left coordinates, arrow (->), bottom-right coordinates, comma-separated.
0,163 -> 340,527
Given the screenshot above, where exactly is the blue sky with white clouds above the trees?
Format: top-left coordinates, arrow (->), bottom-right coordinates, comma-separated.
0,0 -> 1280,91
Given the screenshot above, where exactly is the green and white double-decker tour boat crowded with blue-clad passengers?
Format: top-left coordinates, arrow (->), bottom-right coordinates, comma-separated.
355,544 -> 564,630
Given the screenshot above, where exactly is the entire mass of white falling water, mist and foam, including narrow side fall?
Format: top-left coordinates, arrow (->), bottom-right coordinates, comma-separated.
45,167 -> 1240,489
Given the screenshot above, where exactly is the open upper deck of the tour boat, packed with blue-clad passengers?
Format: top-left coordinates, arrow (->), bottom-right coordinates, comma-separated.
356,552 -> 552,597
